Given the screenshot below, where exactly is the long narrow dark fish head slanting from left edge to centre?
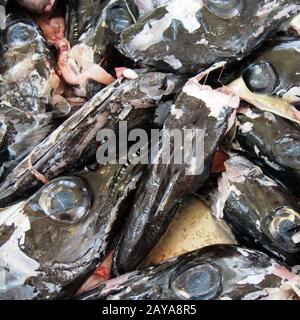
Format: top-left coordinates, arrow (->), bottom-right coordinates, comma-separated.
0,72 -> 181,207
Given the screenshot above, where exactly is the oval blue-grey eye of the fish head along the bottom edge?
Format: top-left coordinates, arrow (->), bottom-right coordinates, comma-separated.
171,263 -> 222,300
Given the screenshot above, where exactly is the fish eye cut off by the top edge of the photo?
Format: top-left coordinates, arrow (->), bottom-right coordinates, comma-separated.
204,0 -> 244,19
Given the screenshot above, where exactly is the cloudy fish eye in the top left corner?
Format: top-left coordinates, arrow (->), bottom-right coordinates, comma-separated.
7,22 -> 37,48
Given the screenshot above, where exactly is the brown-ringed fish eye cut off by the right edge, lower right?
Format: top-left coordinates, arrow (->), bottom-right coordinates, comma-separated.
263,207 -> 300,253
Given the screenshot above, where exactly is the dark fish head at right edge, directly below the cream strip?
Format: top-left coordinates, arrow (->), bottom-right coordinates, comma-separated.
236,108 -> 300,196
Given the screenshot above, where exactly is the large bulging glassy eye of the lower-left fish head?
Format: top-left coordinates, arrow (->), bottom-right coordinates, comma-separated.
38,177 -> 91,224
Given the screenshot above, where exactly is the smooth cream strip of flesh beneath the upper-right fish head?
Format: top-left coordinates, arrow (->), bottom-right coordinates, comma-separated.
226,77 -> 300,124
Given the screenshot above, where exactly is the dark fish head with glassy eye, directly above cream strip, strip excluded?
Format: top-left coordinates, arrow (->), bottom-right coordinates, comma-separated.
242,37 -> 300,105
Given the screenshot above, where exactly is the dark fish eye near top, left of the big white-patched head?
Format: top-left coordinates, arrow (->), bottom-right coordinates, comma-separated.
107,6 -> 133,34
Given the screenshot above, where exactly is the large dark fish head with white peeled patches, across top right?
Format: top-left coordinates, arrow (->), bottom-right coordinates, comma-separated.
118,0 -> 300,74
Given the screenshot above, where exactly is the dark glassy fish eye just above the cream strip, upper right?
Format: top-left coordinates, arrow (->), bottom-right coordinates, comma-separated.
242,62 -> 278,93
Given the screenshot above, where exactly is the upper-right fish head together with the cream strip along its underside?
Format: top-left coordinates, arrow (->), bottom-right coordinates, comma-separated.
228,37 -> 300,124
